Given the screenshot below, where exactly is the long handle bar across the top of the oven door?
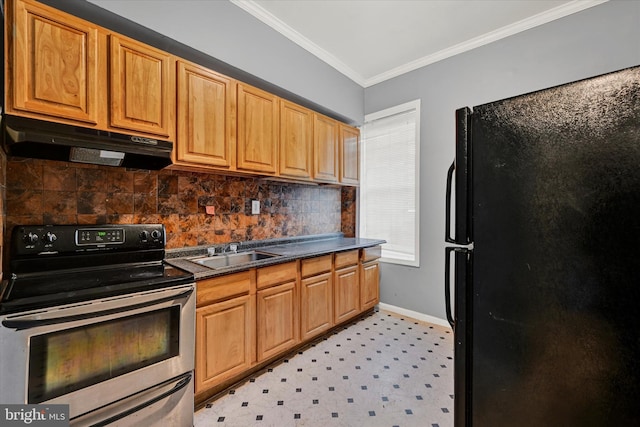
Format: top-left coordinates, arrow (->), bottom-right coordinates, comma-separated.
2,285 -> 194,330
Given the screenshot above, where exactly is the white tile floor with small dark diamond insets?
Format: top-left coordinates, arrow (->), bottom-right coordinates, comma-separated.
195,308 -> 453,427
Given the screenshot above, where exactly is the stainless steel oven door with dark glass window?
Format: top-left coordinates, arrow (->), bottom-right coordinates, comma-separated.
0,284 -> 195,425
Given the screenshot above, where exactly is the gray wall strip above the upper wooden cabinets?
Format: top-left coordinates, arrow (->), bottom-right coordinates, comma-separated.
89,0 -> 364,124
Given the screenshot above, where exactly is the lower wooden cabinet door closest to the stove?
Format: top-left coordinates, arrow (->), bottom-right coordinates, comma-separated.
195,295 -> 255,393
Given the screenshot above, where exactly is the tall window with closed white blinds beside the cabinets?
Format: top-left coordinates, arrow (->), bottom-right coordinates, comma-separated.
359,100 -> 420,267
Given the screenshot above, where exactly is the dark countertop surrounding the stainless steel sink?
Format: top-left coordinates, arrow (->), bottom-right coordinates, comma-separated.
166,233 -> 385,280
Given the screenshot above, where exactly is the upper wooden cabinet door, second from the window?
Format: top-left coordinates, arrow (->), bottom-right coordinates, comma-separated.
313,114 -> 338,182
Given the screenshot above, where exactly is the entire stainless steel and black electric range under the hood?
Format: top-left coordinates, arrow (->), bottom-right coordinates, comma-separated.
0,224 -> 195,427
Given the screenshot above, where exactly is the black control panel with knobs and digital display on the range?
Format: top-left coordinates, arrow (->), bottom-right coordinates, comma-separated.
11,224 -> 166,256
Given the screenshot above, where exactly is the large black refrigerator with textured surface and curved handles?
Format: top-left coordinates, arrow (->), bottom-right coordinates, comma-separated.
445,67 -> 640,427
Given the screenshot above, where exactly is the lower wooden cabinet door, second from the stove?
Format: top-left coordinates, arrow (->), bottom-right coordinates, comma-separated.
256,281 -> 299,362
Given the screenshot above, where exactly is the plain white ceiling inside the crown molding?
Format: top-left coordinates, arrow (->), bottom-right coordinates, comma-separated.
231,0 -> 607,87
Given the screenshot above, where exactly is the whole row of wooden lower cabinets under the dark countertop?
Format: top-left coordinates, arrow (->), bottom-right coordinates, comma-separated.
195,249 -> 379,403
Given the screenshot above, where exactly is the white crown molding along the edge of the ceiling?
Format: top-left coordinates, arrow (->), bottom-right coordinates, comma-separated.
230,0 -> 609,88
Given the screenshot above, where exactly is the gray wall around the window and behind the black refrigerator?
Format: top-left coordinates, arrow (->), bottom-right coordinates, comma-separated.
365,0 -> 640,319
